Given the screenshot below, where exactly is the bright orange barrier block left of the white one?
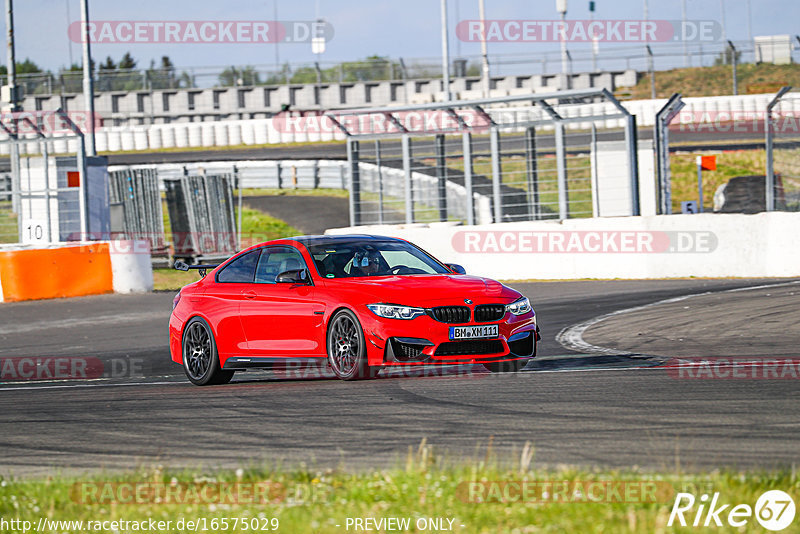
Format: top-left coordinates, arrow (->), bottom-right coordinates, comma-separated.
0,243 -> 114,302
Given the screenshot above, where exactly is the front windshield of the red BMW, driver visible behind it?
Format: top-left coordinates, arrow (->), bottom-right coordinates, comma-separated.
308,241 -> 450,278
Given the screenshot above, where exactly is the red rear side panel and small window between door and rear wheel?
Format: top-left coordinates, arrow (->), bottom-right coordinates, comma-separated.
203,249 -> 261,362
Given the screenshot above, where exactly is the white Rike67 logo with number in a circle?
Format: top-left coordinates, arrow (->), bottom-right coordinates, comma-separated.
667,490 -> 795,532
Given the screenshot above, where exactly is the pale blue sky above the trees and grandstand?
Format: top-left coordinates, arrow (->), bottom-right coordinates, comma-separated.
6,0 -> 800,75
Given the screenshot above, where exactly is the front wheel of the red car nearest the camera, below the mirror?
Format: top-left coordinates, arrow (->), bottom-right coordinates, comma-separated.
328,310 -> 378,380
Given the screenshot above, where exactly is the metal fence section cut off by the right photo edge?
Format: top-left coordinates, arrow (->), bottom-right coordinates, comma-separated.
765,87 -> 800,211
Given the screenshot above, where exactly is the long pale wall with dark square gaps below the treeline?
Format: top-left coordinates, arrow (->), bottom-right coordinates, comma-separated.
23,70 -> 638,126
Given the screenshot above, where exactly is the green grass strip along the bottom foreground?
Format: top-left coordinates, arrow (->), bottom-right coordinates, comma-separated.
0,441 -> 800,533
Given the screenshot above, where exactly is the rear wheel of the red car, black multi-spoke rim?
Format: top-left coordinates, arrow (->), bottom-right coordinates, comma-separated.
181,317 -> 233,386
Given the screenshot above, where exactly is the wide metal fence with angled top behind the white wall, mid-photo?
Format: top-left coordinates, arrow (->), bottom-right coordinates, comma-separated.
336,90 -> 639,225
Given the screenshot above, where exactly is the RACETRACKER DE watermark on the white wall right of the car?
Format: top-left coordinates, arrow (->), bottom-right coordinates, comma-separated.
452,230 -> 718,254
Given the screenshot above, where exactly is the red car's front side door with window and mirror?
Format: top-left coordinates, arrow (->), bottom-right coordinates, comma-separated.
240,246 -> 325,358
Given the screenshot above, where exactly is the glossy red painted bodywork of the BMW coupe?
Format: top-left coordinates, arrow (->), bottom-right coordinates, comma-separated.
170,239 -> 538,372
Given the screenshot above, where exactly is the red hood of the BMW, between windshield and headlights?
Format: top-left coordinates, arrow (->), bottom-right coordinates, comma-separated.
330,275 -> 520,307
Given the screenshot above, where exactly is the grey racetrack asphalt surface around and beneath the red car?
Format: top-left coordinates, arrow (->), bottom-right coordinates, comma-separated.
0,280 -> 800,476
